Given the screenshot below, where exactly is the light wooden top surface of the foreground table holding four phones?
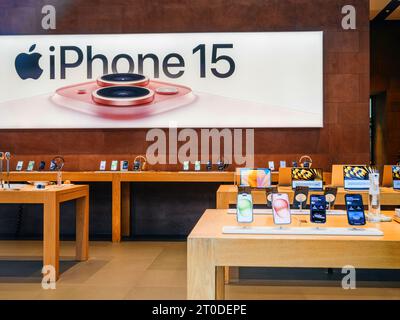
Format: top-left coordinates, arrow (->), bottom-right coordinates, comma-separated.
188,209 -> 400,244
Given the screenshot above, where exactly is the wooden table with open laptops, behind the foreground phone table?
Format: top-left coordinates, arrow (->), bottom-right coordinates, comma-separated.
217,165 -> 400,214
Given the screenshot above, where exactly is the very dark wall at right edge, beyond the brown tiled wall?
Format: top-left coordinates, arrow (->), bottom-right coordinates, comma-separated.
371,21 -> 400,168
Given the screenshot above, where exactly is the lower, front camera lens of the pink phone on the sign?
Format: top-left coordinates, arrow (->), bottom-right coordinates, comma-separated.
92,86 -> 154,107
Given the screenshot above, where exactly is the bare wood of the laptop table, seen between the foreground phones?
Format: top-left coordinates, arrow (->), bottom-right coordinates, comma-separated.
217,185 -> 400,209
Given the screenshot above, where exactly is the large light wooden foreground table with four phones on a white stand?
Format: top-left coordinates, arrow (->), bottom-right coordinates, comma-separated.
187,209 -> 400,299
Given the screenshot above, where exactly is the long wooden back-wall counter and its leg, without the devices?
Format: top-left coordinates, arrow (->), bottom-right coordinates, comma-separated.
3,171 -> 235,242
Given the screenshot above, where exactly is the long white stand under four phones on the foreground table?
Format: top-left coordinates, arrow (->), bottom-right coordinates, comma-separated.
222,226 -> 383,236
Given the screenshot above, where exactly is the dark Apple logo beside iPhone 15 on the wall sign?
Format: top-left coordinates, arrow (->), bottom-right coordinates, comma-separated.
15,44 -> 43,80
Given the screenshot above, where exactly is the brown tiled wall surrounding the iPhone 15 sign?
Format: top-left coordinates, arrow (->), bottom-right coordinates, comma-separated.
0,0 -> 369,170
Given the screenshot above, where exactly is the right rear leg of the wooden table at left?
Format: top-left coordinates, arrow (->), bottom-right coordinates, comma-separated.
76,195 -> 89,261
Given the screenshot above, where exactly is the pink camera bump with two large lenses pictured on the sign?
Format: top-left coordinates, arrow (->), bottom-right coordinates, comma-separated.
52,73 -> 195,119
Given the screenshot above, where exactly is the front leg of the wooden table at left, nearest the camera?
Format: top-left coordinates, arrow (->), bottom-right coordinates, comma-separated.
43,194 -> 60,280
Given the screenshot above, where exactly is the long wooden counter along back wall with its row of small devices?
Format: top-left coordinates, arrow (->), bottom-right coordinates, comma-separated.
0,153 -> 234,242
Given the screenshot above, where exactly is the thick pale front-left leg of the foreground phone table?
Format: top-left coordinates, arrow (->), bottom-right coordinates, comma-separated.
187,238 -> 219,300
